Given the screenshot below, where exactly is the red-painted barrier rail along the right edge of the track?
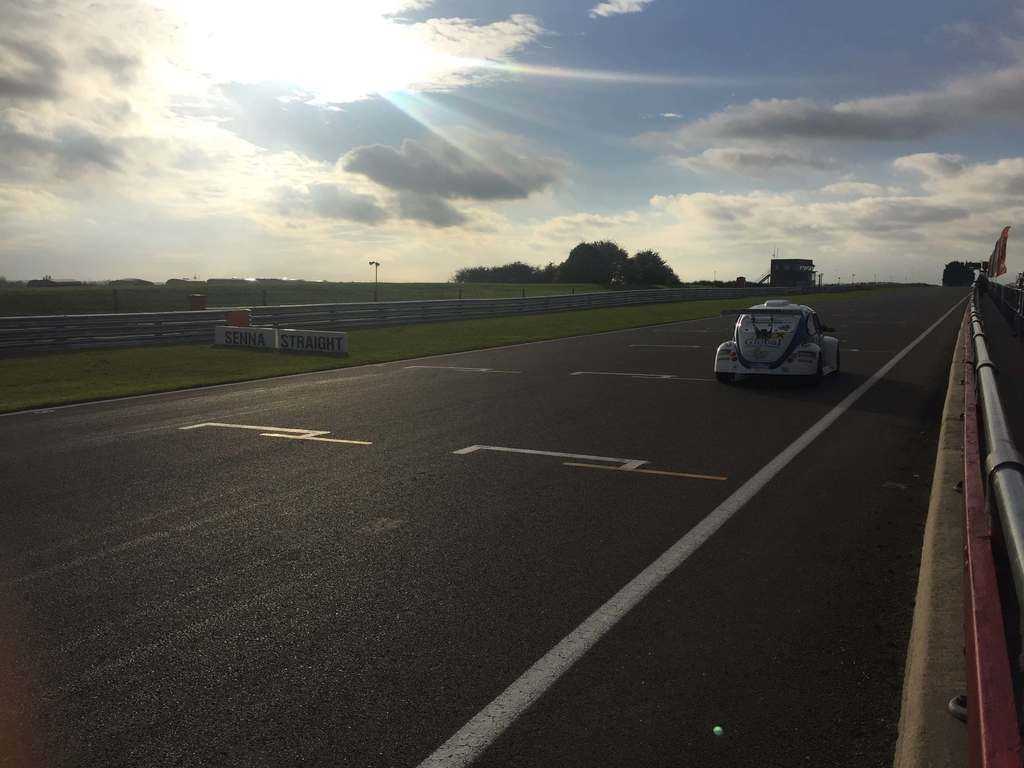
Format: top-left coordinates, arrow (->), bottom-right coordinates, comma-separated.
964,300 -> 1024,768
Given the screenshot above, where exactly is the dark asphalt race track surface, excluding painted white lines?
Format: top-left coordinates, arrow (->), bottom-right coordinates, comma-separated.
0,289 -> 966,767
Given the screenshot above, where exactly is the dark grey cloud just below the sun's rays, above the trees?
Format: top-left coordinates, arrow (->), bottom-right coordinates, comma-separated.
341,138 -> 558,200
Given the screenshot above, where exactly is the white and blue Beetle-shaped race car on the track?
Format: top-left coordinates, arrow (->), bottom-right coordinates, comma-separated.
715,299 -> 839,383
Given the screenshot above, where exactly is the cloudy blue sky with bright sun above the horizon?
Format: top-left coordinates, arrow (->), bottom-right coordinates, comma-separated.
0,0 -> 1024,282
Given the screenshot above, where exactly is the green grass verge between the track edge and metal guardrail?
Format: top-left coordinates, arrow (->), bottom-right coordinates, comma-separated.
0,294 -> 872,413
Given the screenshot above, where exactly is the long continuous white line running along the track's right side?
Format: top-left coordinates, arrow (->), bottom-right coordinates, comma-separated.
419,298 -> 967,768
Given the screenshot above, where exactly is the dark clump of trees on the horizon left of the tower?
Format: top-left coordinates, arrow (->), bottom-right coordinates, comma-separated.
453,240 -> 679,286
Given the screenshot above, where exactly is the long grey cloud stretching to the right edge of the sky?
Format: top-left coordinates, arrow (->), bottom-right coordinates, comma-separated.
638,67 -> 1024,148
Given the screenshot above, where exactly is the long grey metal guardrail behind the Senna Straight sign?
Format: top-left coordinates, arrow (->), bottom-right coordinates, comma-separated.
0,286 -> 856,351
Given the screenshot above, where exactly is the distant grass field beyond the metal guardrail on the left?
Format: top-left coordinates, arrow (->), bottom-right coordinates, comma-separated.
0,283 -> 606,316
